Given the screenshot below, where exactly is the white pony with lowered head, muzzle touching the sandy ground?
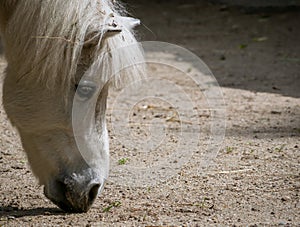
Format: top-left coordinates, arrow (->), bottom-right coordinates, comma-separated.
0,0 -> 144,212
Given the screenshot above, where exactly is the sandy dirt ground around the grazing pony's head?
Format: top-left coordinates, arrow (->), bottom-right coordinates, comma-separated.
0,0 -> 300,226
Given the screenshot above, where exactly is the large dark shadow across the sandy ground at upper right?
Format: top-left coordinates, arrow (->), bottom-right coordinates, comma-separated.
127,0 -> 300,97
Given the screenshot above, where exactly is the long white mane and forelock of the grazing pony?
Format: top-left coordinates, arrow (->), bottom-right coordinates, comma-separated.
3,0 -> 144,90
